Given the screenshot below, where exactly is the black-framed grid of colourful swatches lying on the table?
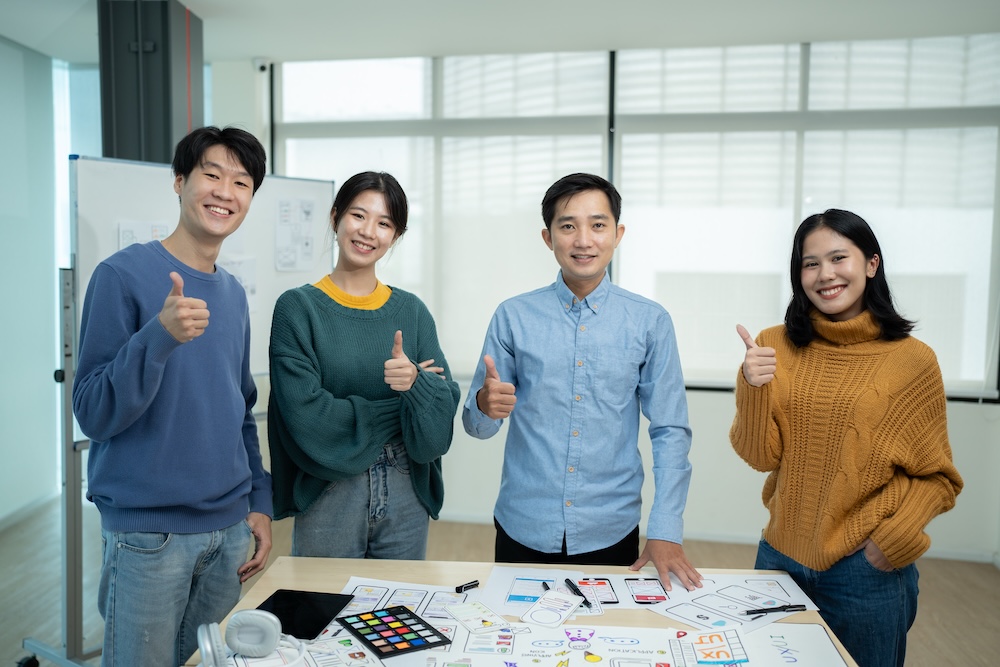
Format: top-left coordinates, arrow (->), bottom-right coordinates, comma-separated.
337,606 -> 451,658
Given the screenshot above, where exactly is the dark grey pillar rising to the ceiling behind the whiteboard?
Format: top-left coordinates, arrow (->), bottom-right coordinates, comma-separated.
97,0 -> 205,163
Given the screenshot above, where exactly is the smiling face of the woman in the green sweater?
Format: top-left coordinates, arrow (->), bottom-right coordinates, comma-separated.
332,190 -> 397,273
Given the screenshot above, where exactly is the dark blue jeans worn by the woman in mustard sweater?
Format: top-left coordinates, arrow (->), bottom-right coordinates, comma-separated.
756,540 -> 919,667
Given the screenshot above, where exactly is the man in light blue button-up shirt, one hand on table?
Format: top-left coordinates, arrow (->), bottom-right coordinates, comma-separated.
462,174 -> 701,590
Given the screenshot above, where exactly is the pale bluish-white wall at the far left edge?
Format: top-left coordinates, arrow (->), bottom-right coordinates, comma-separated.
0,38 -> 60,528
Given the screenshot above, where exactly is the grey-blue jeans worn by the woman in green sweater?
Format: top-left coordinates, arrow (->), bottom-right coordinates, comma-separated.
292,444 -> 430,560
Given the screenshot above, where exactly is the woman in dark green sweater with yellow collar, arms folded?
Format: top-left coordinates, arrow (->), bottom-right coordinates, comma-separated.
267,172 -> 459,559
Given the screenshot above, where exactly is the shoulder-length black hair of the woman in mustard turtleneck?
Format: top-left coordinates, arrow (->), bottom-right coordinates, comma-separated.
785,208 -> 915,347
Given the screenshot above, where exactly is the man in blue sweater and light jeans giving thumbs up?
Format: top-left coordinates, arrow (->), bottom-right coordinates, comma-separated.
73,127 -> 272,667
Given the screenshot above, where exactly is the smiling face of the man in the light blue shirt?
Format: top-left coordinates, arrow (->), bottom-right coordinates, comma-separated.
542,190 -> 625,299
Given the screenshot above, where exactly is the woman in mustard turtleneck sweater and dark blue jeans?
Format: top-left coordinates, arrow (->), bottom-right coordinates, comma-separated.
729,209 -> 962,667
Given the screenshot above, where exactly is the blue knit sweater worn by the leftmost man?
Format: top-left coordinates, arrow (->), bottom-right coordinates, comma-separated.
73,241 -> 271,533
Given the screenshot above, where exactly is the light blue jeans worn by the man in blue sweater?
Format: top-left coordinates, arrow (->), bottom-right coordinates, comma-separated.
97,521 -> 251,667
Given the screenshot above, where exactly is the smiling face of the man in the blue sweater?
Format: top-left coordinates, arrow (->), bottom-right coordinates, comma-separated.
174,144 -> 253,246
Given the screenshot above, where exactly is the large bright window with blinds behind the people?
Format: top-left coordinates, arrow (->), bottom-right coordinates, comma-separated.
276,34 -> 1000,397
